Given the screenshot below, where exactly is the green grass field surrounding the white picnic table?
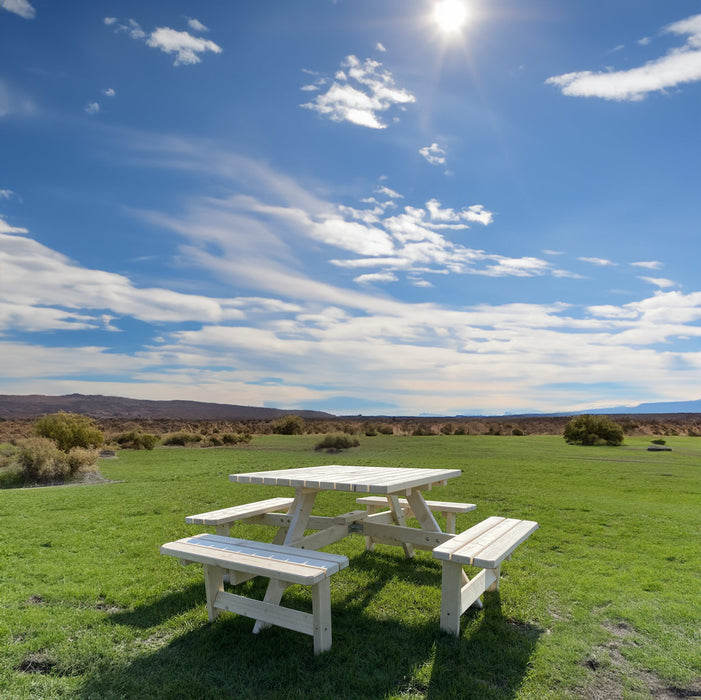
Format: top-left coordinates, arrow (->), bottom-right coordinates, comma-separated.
0,436 -> 701,700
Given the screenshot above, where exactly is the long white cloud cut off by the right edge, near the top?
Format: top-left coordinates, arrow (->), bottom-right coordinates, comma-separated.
545,14 -> 701,101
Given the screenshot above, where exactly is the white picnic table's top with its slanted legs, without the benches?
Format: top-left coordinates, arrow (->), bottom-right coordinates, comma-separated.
229,464 -> 462,632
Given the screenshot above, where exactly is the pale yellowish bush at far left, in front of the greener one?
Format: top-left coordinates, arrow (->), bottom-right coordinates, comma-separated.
17,437 -> 98,483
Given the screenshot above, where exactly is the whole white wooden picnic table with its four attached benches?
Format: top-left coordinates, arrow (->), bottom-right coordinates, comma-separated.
161,465 -> 538,653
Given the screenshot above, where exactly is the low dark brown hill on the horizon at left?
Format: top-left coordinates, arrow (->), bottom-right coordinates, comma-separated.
0,394 -> 335,420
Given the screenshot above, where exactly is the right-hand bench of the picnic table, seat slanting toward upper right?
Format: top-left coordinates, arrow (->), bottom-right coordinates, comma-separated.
433,516 -> 538,636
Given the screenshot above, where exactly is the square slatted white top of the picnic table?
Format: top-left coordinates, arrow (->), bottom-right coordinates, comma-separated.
229,464 -> 462,494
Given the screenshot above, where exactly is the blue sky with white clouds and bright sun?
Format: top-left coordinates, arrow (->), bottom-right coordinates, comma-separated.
0,0 -> 701,415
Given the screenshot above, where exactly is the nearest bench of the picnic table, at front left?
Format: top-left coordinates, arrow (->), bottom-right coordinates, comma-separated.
160,534 -> 348,654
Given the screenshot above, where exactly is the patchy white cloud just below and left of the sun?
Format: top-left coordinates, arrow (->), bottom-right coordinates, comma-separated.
301,55 -> 416,129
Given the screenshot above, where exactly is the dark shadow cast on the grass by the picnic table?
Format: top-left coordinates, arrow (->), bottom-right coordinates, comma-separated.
79,552 -> 540,700
